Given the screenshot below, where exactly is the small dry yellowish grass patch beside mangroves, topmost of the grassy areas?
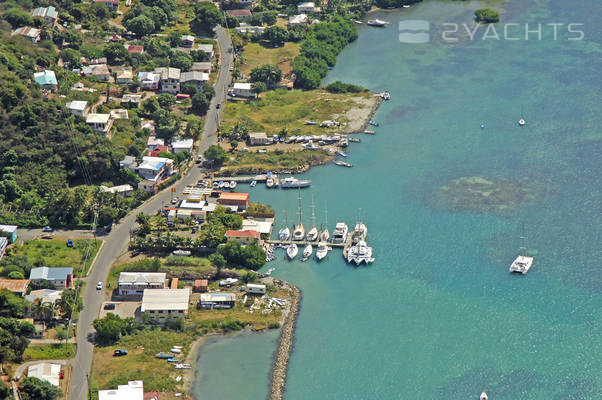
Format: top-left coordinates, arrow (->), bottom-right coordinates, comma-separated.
239,42 -> 300,76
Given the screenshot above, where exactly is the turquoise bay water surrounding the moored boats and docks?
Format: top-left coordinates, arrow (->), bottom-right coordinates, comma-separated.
198,0 -> 602,400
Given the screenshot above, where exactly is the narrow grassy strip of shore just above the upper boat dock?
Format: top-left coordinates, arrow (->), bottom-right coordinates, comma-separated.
224,150 -> 334,175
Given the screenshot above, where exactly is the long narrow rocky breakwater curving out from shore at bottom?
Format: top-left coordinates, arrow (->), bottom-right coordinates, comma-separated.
269,279 -> 301,400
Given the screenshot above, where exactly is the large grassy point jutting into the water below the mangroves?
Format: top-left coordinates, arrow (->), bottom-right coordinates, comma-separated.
222,89 -> 373,135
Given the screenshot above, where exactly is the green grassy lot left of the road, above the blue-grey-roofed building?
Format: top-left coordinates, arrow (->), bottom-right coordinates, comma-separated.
14,239 -> 102,277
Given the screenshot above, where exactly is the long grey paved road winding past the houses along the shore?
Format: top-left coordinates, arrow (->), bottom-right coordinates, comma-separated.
70,27 -> 233,400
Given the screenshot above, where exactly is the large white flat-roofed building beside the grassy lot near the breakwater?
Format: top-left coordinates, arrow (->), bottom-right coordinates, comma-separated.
141,289 -> 190,323
